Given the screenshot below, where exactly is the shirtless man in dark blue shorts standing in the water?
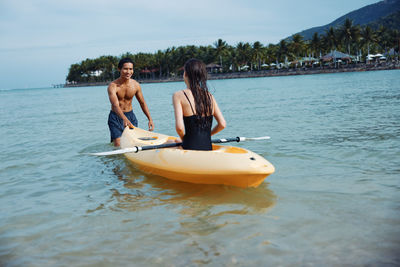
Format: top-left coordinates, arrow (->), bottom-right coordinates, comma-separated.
107,58 -> 154,146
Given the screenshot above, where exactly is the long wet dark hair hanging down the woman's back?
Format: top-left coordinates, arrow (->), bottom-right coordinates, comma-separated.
184,58 -> 213,126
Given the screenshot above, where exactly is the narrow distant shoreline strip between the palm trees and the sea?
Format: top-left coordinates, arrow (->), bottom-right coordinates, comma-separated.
63,62 -> 400,87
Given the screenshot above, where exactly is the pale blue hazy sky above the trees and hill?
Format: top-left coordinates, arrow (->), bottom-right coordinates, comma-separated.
0,0 -> 379,90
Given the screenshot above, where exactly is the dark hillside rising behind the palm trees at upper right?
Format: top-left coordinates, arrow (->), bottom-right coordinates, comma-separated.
289,0 -> 400,40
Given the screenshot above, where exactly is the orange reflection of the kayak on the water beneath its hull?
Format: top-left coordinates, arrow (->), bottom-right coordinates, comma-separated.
125,160 -> 276,214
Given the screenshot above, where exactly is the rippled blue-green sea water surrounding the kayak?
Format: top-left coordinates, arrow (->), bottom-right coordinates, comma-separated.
0,70 -> 400,266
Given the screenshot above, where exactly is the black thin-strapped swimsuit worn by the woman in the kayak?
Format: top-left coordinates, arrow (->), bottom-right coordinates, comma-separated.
182,92 -> 213,150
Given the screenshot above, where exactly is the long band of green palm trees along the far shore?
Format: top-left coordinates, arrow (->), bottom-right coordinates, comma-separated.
66,19 -> 400,83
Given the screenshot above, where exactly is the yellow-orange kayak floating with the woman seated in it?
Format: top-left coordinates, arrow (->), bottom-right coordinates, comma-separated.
121,127 -> 275,187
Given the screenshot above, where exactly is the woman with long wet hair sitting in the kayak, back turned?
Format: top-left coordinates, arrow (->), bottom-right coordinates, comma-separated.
172,59 -> 226,150
